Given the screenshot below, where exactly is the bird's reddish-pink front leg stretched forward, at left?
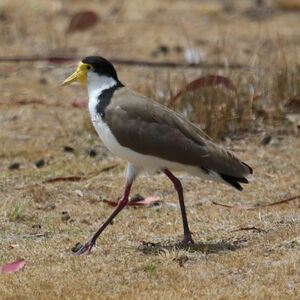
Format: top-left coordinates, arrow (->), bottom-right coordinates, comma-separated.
76,183 -> 132,255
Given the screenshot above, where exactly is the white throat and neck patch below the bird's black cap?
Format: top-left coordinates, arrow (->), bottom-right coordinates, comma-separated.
86,72 -> 117,99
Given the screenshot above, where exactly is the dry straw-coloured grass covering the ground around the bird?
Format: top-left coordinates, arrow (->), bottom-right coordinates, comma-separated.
0,0 -> 300,299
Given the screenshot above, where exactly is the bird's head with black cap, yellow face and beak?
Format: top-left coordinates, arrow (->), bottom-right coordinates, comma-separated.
63,56 -> 119,85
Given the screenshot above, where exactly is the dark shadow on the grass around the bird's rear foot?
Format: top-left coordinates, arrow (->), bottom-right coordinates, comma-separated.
138,239 -> 247,254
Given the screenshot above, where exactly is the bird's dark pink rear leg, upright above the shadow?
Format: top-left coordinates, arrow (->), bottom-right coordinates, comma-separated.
164,169 -> 194,247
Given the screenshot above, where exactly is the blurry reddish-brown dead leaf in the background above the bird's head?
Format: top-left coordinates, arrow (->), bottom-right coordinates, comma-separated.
67,10 -> 99,33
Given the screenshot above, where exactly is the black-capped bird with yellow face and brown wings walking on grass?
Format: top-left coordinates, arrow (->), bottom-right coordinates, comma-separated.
62,56 -> 253,254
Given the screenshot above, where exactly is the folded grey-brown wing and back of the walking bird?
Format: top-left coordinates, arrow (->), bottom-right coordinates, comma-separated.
105,88 -> 251,177
